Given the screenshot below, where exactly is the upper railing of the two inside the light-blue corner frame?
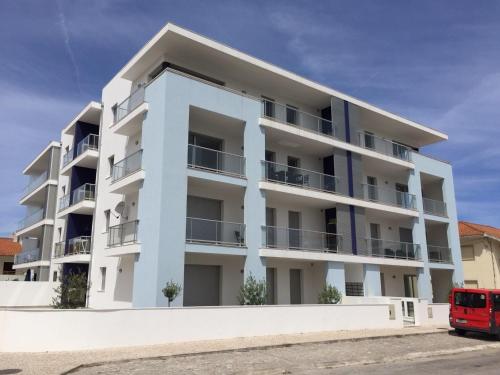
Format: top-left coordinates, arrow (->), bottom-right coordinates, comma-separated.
188,144 -> 245,177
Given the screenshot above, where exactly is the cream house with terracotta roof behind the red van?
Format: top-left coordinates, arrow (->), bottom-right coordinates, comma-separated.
459,221 -> 500,289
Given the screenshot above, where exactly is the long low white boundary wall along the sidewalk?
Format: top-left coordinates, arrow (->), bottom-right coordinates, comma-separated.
0,304 -> 403,352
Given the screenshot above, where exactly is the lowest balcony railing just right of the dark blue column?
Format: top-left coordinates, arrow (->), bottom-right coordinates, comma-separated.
357,238 -> 421,260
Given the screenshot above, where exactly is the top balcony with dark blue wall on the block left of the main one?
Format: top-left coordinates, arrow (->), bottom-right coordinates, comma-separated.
61,134 -> 99,175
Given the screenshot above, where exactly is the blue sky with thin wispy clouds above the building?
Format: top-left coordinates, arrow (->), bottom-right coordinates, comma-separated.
0,0 -> 500,234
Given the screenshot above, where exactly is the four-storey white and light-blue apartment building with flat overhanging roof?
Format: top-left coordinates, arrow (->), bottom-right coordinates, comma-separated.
13,24 -> 463,308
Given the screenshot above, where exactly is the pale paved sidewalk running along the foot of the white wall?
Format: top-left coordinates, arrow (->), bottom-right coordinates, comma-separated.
0,327 -> 449,375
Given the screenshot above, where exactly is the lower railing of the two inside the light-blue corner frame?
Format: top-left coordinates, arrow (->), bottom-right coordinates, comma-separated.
186,217 -> 245,246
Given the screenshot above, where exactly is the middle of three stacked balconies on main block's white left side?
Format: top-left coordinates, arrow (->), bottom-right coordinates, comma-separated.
110,150 -> 145,194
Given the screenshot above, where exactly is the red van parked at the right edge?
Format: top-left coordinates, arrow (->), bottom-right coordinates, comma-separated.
450,288 -> 500,337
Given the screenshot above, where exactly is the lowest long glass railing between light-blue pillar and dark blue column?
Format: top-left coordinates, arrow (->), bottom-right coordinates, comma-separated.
262,226 -> 342,253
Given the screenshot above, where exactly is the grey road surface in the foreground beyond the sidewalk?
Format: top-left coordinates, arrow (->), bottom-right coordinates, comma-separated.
73,333 -> 500,375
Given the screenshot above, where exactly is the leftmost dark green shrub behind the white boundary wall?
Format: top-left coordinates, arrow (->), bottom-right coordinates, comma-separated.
52,271 -> 89,309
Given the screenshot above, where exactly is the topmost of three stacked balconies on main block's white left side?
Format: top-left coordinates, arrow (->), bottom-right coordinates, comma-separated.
111,87 -> 148,136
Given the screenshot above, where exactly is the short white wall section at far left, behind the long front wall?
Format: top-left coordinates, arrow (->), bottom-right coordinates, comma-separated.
0,281 -> 55,308
